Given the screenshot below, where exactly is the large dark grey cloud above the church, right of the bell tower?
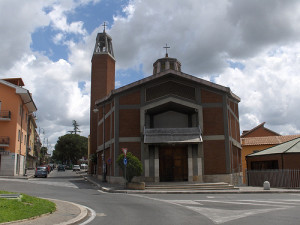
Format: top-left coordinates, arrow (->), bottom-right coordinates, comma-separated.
110,0 -> 300,75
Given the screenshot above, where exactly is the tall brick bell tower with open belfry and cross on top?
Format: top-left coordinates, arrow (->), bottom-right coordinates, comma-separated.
90,22 -> 116,169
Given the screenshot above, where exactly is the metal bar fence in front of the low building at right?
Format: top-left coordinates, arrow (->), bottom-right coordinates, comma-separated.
247,169 -> 300,188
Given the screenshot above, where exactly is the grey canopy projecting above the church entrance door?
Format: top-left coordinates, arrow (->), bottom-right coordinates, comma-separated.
144,127 -> 203,144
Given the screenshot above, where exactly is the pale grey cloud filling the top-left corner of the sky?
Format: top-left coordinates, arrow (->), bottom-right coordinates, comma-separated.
0,0 -> 50,72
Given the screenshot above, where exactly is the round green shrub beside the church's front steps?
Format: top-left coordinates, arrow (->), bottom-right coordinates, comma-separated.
117,152 -> 143,182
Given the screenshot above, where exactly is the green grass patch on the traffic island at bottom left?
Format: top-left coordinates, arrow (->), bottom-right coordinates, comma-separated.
0,191 -> 56,223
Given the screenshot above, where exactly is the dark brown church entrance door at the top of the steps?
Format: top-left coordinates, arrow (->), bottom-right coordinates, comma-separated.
159,145 -> 188,182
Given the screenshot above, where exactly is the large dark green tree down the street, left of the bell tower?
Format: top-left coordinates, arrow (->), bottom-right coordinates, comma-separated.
52,134 -> 88,164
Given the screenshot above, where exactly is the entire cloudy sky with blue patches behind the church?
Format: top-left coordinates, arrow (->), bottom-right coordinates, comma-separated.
0,0 -> 300,151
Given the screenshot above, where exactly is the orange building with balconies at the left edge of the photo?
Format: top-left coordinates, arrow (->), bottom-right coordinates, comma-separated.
0,78 -> 37,176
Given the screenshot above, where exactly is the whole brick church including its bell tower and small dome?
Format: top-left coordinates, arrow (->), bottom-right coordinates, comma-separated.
90,26 -> 242,184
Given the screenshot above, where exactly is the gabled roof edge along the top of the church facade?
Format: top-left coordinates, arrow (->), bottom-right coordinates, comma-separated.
95,69 -> 241,105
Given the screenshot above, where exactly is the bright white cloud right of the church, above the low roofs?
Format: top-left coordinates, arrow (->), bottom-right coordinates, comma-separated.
215,43 -> 300,134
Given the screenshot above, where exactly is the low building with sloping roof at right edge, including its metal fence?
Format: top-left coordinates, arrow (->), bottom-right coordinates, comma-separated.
246,137 -> 300,188
